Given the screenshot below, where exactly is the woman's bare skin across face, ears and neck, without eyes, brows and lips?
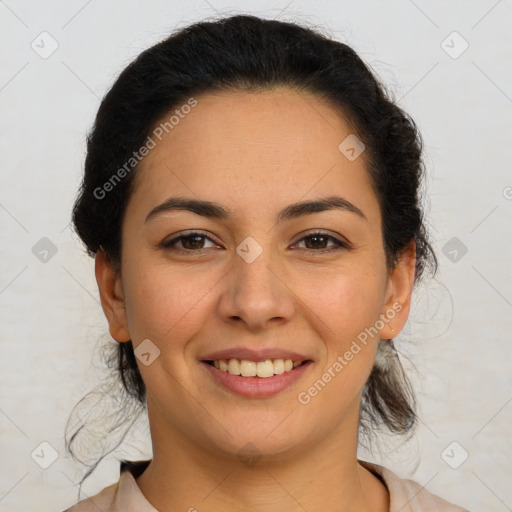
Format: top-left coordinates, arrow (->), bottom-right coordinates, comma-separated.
96,89 -> 415,512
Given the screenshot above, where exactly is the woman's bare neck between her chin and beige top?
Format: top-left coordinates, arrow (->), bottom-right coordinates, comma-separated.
136,402 -> 389,512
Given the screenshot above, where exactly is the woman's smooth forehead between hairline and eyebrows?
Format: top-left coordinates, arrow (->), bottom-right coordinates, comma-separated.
127,89 -> 377,228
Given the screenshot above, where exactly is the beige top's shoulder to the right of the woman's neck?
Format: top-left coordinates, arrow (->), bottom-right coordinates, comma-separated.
359,461 -> 469,512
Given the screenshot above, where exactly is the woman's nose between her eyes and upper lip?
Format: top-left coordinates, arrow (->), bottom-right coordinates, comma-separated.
218,244 -> 296,331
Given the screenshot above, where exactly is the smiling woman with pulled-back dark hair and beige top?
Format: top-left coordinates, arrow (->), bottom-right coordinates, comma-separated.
62,16 -> 470,512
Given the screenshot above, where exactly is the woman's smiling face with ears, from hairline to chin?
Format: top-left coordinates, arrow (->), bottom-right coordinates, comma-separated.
97,90 -> 414,456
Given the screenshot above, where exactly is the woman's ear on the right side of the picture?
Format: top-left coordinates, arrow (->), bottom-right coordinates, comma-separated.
380,239 -> 416,340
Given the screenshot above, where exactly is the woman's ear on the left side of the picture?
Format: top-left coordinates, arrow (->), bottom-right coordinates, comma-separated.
94,247 -> 130,342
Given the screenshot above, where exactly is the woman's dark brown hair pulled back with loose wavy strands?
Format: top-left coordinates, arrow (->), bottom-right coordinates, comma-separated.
67,15 -> 437,488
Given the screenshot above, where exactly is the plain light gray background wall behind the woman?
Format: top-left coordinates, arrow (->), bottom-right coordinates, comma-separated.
0,0 -> 512,512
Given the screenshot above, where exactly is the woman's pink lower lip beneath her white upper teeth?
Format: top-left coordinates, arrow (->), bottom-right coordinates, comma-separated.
201,361 -> 312,398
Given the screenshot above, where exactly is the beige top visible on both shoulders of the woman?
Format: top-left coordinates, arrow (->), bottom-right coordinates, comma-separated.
64,461 -> 468,512
